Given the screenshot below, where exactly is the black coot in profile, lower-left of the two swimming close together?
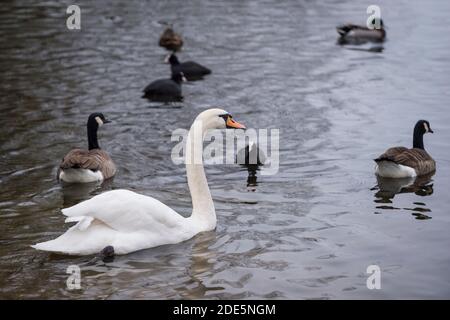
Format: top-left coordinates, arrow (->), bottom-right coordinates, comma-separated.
142,72 -> 187,101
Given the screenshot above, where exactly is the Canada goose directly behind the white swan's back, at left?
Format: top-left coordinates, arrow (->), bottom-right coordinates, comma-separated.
58,113 -> 116,183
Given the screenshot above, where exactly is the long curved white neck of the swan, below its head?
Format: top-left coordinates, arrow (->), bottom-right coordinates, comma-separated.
185,119 -> 216,230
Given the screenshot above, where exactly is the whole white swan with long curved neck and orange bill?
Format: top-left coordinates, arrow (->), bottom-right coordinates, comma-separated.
32,109 -> 245,255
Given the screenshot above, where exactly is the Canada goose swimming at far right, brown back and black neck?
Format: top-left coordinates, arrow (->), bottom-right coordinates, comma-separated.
375,120 -> 436,178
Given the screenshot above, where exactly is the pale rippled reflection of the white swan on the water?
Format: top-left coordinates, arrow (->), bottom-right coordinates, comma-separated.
75,231 -> 225,299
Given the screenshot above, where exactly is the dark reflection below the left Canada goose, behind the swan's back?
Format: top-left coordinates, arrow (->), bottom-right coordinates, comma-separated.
61,177 -> 114,208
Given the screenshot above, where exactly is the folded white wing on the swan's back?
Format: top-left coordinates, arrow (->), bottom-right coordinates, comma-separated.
62,190 -> 184,233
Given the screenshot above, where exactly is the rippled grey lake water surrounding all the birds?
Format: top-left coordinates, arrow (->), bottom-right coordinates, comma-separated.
0,0 -> 450,299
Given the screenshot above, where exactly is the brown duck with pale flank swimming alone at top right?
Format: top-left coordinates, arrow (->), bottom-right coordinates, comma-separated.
336,19 -> 386,44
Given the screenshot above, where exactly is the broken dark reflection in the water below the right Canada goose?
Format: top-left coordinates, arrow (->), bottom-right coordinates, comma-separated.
372,172 -> 434,220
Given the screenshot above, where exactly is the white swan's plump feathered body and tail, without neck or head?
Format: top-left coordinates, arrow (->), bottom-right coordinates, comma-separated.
34,190 -> 204,255
